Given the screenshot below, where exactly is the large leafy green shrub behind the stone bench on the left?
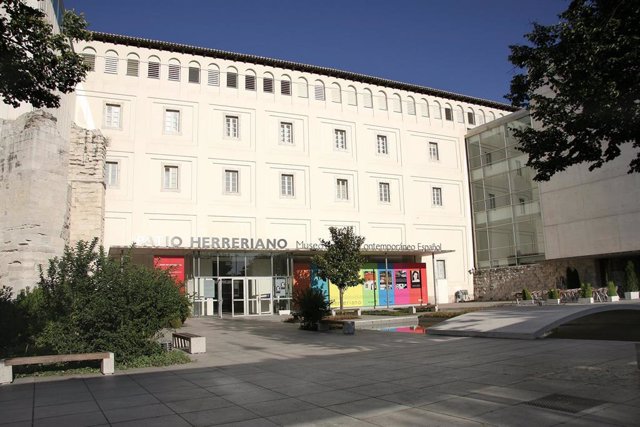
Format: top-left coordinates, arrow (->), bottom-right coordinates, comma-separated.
25,240 -> 189,363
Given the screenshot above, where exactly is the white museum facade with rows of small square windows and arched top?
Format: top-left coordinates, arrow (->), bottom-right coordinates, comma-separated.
75,33 -> 510,312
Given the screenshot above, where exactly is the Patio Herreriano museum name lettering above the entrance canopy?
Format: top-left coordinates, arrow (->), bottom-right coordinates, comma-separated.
135,236 -> 442,252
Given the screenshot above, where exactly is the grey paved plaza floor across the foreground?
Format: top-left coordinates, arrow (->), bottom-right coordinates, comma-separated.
0,317 -> 640,427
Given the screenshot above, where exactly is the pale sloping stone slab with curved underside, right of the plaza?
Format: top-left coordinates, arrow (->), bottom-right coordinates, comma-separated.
428,301 -> 640,339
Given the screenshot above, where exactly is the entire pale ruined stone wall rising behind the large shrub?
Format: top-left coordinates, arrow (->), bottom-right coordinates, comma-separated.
0,111 -> 106,296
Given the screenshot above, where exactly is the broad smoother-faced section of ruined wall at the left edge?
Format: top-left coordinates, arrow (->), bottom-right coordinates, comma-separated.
0,111 -> 69,293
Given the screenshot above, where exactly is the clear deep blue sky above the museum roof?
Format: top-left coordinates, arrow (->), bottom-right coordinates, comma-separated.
65,0 -> 568,102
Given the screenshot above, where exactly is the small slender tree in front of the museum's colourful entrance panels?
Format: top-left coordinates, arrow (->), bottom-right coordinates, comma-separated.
313,227 -> 365,311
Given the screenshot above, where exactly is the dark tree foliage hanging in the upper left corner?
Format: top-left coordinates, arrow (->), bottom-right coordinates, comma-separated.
0,0 -> 91,108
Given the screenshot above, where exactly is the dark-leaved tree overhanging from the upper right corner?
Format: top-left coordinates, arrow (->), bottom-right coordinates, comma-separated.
506,0 -> 640,181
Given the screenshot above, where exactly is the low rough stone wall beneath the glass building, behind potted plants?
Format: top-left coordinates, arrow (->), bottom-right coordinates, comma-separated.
473,259 -> 601,301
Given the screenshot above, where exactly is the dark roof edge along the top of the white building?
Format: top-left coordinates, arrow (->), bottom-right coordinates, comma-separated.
92,31 -> 517,111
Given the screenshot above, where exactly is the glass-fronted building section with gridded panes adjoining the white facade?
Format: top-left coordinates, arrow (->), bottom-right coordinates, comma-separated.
466,111 -> 545,269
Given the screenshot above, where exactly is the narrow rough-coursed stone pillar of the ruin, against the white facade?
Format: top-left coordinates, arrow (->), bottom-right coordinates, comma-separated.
69,125 -> 107,245
